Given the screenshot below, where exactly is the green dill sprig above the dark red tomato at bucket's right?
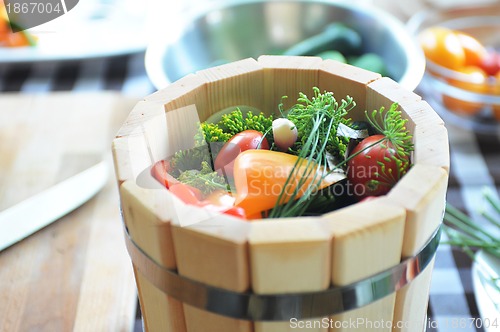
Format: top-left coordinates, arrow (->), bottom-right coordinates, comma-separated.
365,103 -> 413,157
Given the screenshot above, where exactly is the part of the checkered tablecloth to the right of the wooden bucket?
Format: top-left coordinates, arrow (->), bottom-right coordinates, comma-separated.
423,122 -> 500,332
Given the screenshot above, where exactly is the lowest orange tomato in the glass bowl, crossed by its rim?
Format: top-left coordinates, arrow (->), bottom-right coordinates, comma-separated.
443,66 -> 488,115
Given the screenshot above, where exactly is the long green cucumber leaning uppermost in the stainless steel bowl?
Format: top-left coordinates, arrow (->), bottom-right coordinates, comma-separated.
283,23 -> 362,56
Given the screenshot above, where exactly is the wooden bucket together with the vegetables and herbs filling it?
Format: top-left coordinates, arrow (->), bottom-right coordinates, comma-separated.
113,56 -> 449,331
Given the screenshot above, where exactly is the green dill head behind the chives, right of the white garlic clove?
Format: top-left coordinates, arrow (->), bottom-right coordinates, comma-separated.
286,87 -> 356,160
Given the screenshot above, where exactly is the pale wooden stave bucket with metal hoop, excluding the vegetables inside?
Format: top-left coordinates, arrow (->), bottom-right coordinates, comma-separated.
113,56 -> 449,332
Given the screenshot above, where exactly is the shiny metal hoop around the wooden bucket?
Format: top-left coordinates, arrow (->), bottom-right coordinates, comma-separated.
125,224 -> 441,321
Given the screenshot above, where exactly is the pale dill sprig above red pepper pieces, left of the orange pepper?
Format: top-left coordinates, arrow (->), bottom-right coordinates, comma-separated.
177,161 -> 228,195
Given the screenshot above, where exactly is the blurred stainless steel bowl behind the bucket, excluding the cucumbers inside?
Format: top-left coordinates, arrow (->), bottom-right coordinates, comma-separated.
146,0 -> 425,90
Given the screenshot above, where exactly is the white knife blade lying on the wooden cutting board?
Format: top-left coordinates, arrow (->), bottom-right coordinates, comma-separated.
0,161 -> 108,251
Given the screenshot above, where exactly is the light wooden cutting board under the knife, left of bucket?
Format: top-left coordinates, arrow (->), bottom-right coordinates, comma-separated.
0,92 -> 137,332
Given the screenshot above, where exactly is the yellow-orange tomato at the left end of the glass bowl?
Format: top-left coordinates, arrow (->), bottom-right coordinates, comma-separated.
418,26 -> 465,69
